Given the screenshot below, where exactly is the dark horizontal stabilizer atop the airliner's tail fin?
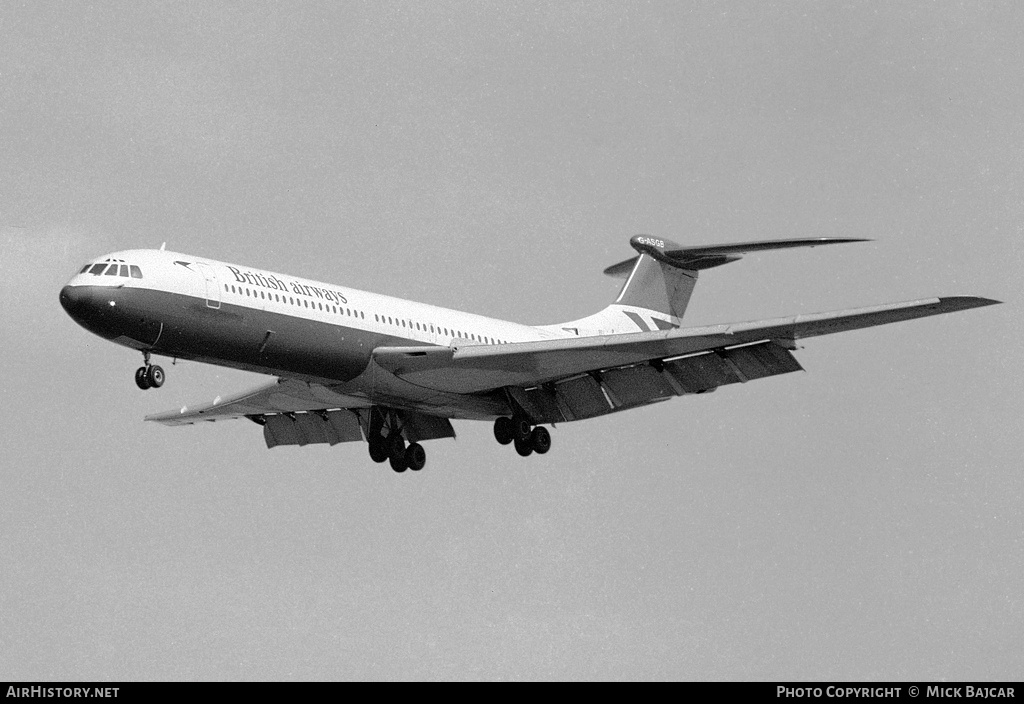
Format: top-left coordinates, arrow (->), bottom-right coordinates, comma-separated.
604,234 -> 870,278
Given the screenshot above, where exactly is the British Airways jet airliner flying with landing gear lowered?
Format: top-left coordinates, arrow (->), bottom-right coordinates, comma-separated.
59,235 -> 999,473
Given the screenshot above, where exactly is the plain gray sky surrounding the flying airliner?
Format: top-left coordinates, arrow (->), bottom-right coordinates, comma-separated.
0,2 -> 1024,679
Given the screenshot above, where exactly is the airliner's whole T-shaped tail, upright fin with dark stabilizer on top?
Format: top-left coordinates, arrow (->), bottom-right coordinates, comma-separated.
544,234 -> 869,336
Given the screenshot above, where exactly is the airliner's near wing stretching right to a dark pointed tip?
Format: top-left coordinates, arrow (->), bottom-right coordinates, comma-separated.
374,296 -> 998,394
